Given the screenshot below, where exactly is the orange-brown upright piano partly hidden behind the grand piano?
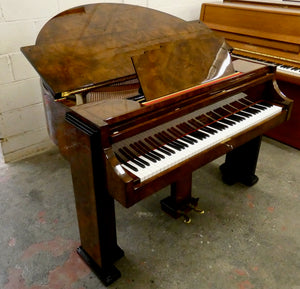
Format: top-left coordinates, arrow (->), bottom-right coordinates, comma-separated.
200,0 -> 300,149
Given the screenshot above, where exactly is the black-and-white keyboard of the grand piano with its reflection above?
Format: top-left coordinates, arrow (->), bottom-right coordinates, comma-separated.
113,93 -> 282,182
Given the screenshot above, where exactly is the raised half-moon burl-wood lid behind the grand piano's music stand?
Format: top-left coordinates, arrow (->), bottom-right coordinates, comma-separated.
21,3 -> 232,98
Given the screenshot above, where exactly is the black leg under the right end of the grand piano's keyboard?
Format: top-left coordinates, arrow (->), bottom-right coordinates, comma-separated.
220,136 -> 261,186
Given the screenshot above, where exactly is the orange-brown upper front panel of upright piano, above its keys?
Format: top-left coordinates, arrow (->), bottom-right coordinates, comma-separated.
200,2 -> 300,67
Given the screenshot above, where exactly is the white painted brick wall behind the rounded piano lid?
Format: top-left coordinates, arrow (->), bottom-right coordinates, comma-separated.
0,0 -> 214,162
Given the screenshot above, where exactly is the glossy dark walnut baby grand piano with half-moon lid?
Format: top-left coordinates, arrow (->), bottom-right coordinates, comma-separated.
22,4 -> 292,285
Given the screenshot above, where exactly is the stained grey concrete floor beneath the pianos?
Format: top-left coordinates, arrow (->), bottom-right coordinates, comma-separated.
0,138 -> 300,289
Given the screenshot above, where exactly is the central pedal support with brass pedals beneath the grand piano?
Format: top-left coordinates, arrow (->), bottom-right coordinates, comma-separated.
160,174 -> 198,223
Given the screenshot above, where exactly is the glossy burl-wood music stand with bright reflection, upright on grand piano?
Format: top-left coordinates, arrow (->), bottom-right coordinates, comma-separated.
133,33 -> 235,101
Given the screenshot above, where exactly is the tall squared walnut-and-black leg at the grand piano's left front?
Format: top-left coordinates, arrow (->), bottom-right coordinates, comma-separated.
68,115 -> 124,286
